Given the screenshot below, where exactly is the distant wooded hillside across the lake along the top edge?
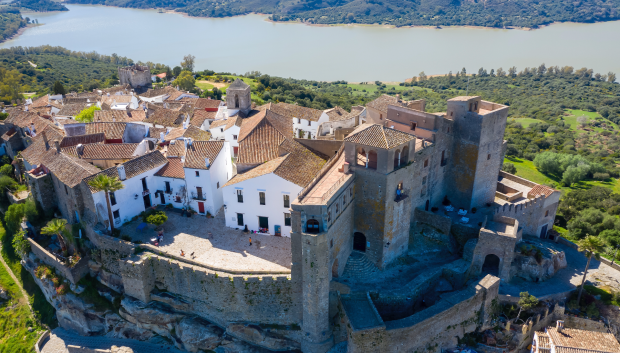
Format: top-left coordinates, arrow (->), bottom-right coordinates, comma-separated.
68,0 -> 620,28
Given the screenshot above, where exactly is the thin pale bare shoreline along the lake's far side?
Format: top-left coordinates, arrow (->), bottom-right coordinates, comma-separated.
61,2 -> 620,32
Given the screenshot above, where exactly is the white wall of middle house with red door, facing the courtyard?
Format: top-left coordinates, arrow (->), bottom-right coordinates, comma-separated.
184,143 -> 232,215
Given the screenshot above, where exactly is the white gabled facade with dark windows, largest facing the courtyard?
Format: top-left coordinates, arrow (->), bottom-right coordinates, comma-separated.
223,174 -> 302,237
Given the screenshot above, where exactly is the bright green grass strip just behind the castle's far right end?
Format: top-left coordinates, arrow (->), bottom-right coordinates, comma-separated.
504,157 -> 620,193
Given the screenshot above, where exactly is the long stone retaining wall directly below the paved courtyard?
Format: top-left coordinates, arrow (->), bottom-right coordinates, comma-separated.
119,253 -> 301,326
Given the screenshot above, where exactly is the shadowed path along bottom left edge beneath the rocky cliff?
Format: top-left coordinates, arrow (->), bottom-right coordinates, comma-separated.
41,328 -> 186,353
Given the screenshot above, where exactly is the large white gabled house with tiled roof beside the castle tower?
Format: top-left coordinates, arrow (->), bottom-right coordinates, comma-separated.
223,146 -> 325,237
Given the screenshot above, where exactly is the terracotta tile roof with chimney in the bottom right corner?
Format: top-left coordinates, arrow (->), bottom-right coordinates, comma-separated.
547,327 -> 620,353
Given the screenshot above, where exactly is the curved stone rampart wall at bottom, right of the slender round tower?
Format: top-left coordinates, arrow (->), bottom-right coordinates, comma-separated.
348,276 -> 499,353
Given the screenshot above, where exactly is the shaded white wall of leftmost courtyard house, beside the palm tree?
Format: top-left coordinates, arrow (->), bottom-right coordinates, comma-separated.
93,165 -> 164,227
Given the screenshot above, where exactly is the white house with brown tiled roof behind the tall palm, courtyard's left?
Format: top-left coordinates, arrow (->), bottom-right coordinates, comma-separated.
84,151 -> 168,227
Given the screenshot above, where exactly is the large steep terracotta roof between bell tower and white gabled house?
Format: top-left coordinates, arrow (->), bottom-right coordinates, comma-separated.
237,110 -> 293,164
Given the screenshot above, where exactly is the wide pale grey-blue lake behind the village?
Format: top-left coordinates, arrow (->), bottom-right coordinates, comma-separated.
0,5 -> 620,82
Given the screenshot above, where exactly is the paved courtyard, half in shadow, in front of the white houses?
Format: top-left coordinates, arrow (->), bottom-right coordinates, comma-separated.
121,210 -> 291,274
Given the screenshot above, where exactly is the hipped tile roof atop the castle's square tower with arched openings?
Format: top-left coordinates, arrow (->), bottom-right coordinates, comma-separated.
344,124 -> 415,149
